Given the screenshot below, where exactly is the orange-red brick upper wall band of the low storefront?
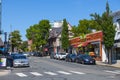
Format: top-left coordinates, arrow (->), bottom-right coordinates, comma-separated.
70,31 -> 103,47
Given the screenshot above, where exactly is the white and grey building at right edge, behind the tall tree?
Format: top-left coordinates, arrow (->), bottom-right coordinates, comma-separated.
112,11 -> 120,60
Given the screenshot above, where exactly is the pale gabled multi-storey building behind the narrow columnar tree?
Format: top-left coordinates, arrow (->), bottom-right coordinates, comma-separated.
48,21 -> 73,53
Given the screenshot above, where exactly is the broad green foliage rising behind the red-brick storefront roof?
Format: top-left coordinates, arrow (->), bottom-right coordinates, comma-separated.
72,19 -> 101,37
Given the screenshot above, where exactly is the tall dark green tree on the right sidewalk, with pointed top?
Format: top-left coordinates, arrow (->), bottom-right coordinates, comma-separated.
91,2 -> 115,64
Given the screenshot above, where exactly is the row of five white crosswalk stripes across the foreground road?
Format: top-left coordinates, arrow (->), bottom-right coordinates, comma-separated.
15,71 -> 86,77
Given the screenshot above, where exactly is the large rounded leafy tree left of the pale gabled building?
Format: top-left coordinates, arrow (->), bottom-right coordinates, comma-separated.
26,20 -> 51,51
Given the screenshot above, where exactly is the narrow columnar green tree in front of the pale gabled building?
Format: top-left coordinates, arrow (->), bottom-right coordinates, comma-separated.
61,19 -> 69,51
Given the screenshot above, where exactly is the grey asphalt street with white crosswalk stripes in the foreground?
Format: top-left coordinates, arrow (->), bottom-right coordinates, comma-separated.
0,57 -> 120,80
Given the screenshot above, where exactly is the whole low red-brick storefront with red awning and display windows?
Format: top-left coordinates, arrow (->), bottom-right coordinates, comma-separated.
70,31 -> 106,61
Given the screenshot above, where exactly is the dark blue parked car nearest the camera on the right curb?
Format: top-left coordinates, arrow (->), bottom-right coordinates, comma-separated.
76,54 -> 96,64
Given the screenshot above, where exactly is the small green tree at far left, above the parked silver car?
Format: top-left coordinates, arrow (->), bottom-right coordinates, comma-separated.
10,30 -> 22,52
